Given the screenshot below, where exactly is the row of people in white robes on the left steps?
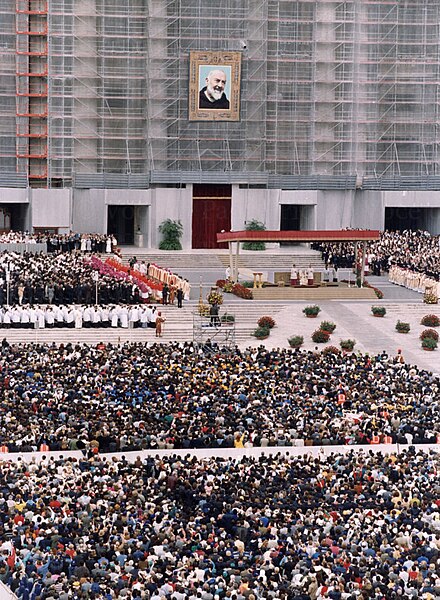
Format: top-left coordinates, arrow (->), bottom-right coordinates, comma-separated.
0,304 -> 165,329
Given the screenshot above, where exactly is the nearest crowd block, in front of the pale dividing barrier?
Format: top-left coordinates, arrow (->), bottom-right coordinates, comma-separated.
0,447 -> 440,600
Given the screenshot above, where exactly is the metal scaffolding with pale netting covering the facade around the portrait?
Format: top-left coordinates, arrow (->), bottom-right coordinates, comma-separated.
0,0 -> 440,187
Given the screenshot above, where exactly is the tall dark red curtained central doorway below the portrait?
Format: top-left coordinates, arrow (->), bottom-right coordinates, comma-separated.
192,184 -> 232,248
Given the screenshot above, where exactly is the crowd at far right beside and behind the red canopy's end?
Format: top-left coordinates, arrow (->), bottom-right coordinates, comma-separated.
312,230 -> 440,281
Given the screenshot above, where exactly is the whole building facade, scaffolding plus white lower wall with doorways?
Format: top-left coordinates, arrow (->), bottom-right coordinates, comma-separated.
0,0 -> 440,247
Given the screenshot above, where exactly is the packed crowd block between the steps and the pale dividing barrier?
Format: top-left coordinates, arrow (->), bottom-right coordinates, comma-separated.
0,340 -> 440,452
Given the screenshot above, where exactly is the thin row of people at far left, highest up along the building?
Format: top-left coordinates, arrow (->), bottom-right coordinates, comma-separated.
0,231 -> 117,253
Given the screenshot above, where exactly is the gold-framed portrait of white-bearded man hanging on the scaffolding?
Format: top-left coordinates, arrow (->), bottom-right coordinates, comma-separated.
188,51 -> 241,121
